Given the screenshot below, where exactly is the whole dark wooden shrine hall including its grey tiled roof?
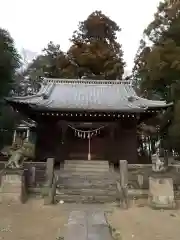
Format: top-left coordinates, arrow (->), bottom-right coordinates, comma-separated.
6,78 -> 171,163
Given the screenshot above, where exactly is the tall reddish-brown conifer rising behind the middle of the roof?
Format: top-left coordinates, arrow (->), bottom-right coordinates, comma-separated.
67,11 -> 125,79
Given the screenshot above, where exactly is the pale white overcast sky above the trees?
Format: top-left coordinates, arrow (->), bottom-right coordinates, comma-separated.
0,0 -> 159,69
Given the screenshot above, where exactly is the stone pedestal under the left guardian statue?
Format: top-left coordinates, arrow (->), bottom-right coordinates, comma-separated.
0,169 -> 25,203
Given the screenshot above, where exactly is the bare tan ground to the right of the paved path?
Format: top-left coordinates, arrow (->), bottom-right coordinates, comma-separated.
108,203 -> 180,240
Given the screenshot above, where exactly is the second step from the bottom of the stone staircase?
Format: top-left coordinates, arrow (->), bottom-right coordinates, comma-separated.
56,188 -> 117,196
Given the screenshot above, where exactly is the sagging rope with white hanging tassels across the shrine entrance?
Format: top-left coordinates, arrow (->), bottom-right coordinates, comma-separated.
68,125 -> 107,138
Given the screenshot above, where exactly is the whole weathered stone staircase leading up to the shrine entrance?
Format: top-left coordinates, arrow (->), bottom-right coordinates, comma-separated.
56,160 -> 117,203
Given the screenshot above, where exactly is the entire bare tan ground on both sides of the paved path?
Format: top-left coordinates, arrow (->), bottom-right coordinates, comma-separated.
0,200 -> 180,240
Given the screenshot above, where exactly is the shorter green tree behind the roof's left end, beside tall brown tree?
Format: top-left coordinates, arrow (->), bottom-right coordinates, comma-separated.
13,42 -> 63,96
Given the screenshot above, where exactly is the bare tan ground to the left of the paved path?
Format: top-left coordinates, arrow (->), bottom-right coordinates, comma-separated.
0,200 -> 69,240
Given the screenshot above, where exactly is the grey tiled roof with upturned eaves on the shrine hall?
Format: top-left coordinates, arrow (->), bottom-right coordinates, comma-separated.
7,78 -> 172,112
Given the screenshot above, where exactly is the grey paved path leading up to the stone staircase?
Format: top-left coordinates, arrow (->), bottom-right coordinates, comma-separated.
64,210 -> 112,240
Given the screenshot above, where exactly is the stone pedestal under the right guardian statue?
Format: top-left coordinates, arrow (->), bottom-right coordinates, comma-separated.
148,176 -> 176,209
